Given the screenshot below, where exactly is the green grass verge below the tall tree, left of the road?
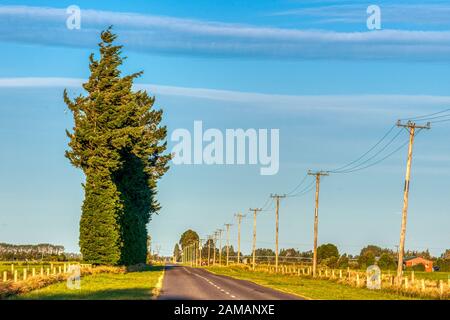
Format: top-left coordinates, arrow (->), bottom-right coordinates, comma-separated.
12,266 -> 163,300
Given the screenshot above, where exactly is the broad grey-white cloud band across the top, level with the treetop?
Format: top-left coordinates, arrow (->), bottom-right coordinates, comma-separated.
0,6 -> 450,60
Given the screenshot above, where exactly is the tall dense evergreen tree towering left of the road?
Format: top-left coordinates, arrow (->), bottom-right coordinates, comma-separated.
64,28 -> 170,265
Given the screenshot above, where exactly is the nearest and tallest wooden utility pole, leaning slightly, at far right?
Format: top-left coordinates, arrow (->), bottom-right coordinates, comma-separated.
396,120 -> 431,285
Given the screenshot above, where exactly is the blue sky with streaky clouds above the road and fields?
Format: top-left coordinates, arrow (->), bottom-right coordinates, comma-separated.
0,0 -> 450,254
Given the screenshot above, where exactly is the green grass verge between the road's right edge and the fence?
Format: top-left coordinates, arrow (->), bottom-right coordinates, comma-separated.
206,267 -> 420,300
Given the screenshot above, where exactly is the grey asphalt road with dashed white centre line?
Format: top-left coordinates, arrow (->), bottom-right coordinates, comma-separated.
158,265 -> 301,300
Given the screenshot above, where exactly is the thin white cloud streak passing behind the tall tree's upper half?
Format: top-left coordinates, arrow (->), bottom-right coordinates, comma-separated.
0,77 -> 450,118
